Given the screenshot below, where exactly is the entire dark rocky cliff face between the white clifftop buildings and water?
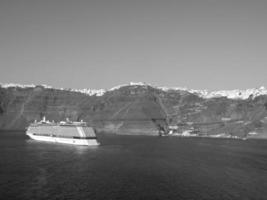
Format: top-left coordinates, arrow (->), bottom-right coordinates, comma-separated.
0,85 -> 267,137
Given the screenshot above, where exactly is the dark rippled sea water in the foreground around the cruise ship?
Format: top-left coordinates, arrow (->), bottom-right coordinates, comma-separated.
0,132 -> 267,200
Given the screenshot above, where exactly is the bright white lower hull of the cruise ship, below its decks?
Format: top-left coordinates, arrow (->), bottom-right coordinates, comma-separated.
26,132 -> 99,146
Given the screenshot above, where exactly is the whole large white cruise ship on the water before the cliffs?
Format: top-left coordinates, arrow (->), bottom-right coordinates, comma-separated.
26,117 -> 99,146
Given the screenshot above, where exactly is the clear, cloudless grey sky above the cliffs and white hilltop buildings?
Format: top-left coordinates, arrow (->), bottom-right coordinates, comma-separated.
0,0 -> 267,90
